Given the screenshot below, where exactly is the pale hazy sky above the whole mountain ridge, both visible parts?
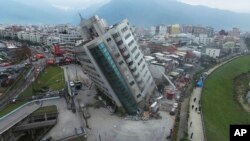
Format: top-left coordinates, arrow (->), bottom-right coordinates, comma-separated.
14,0 -> 250,13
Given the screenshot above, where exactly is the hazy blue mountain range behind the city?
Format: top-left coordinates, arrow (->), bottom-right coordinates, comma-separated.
0,0 -> 250,30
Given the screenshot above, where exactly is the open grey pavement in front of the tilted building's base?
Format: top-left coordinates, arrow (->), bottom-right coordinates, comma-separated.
85,108 -> 174,141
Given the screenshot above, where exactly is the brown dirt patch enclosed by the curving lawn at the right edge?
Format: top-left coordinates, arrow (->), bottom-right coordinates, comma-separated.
233,72 -> 250,113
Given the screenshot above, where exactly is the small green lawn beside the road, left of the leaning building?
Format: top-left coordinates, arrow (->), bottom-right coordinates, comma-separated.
21,66 -> 65,97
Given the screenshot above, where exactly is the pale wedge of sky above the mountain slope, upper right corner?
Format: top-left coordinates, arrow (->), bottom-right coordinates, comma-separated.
177,0 -> 250,13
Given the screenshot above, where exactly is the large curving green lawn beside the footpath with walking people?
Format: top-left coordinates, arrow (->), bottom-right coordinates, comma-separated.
201,55 -> 250,141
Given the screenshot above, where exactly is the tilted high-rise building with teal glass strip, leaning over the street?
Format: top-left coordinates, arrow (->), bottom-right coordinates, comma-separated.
78,16 -> 155,115
